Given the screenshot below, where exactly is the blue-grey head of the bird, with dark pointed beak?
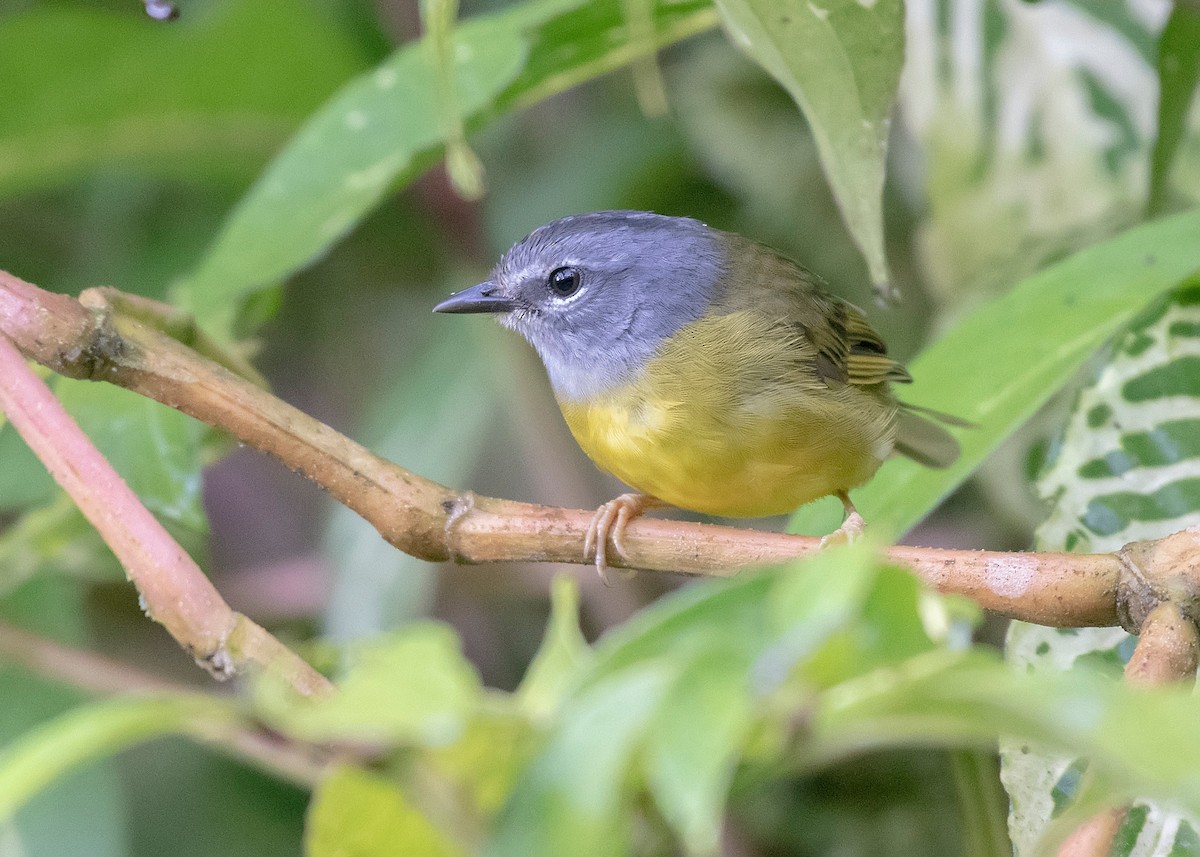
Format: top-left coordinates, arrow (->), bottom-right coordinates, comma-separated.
433,211 -> 725,401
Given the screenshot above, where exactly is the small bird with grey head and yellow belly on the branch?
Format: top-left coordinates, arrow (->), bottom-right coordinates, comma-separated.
433,211 -> 959,576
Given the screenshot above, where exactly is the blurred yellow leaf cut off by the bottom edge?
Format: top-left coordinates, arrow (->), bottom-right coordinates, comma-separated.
304,765 -> 466,857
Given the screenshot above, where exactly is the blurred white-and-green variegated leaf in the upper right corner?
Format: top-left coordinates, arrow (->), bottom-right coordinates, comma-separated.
898,0 -> 1200,298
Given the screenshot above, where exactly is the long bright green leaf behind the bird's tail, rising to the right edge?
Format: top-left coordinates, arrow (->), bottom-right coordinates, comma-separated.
791,210 -> 1200,534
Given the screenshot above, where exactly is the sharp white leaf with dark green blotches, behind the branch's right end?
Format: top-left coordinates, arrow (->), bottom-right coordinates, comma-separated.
1002,281 -> 1200,857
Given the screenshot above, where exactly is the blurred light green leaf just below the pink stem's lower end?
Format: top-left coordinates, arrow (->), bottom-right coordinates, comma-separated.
256,622 -> 482,745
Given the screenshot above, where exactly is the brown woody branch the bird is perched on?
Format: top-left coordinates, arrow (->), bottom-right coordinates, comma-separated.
0,272 -> 1200,633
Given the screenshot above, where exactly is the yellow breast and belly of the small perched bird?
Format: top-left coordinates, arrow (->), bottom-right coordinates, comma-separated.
559,313 -> 896,517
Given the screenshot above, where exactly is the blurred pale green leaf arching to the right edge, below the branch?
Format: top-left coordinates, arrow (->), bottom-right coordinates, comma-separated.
799,649 -> 1200,813
